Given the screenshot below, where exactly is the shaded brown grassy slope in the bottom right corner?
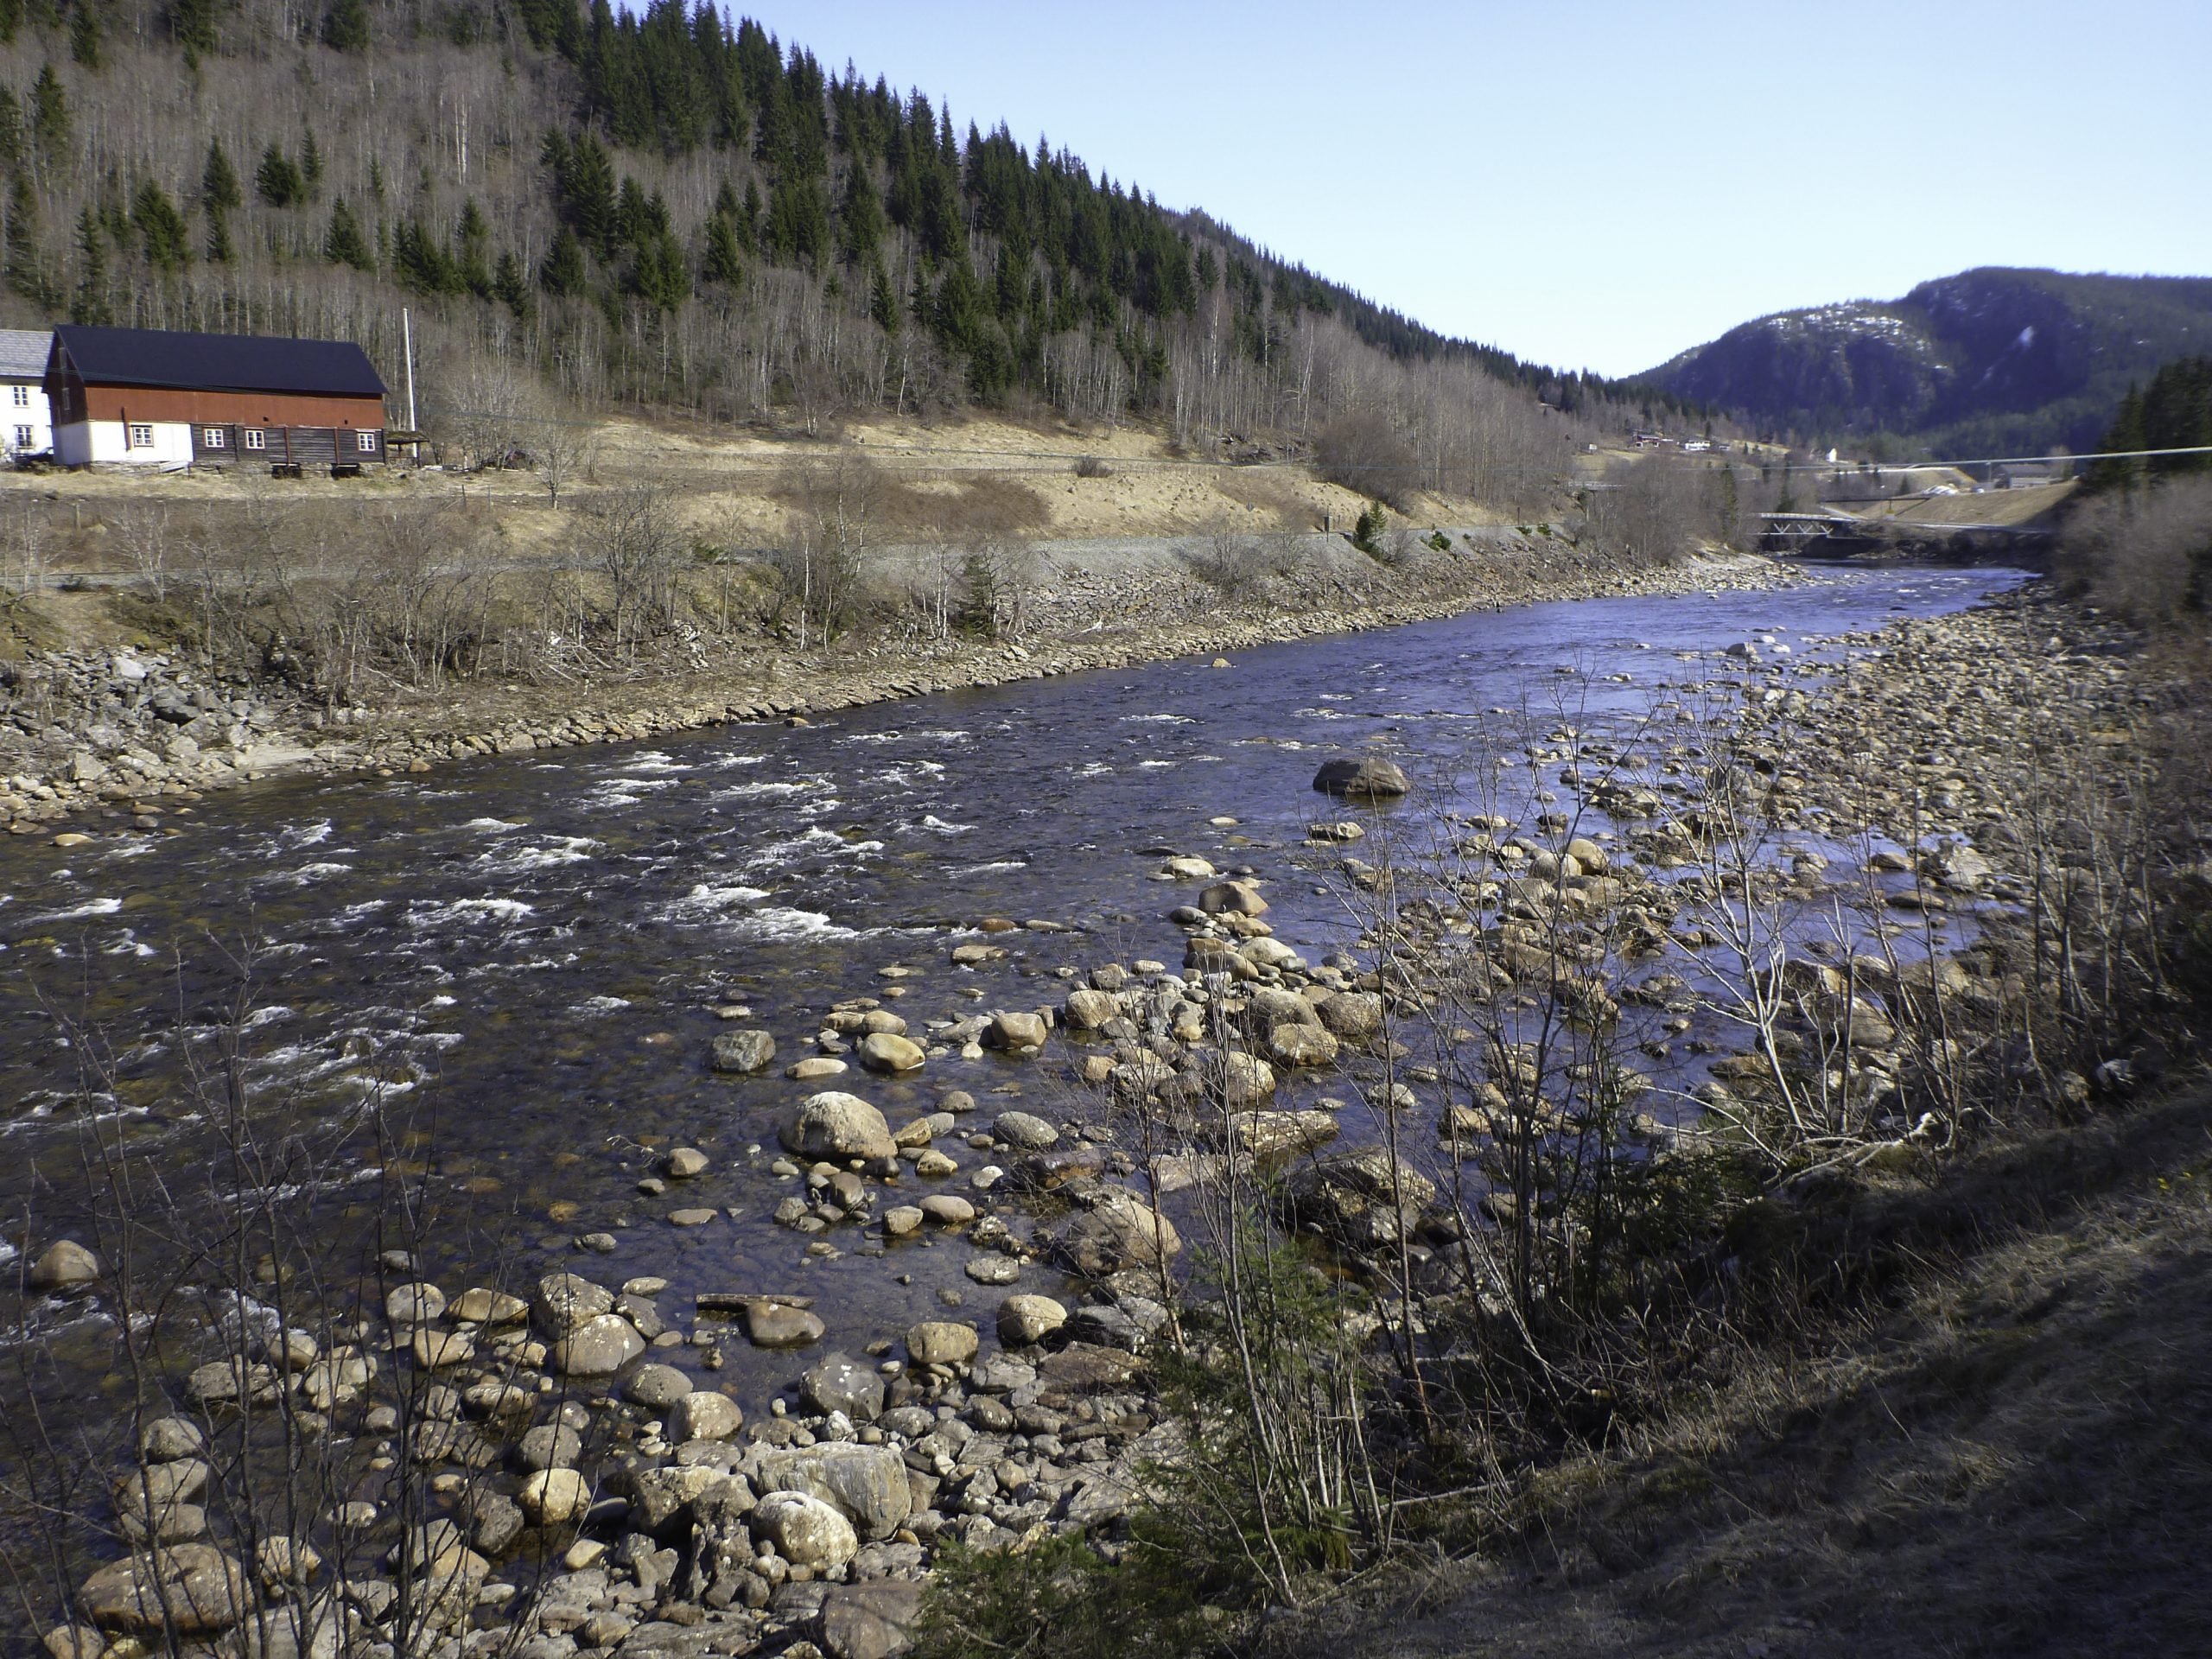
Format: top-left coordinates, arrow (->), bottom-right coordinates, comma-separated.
1294,1084 -> 2212,1659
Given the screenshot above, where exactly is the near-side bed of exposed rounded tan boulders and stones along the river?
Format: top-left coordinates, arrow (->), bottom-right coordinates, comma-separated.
27,562 -> 2159,1659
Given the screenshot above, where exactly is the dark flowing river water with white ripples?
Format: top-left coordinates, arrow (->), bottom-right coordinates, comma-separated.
0,566 -> 2019,1442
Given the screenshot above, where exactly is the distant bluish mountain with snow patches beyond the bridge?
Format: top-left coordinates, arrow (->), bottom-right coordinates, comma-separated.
1635,265 -> 2212,455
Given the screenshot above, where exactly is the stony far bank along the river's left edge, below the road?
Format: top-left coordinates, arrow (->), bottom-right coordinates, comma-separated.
0,539 -> 1802,834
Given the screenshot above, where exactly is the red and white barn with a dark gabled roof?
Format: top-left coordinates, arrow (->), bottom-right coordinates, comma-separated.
47,323 -> 385,478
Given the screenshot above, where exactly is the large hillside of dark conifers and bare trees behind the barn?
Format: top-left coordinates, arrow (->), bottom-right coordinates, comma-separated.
0,0 -> 1672,506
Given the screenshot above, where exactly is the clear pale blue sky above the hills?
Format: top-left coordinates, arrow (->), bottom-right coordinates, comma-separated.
734,0 -> 2212,374
